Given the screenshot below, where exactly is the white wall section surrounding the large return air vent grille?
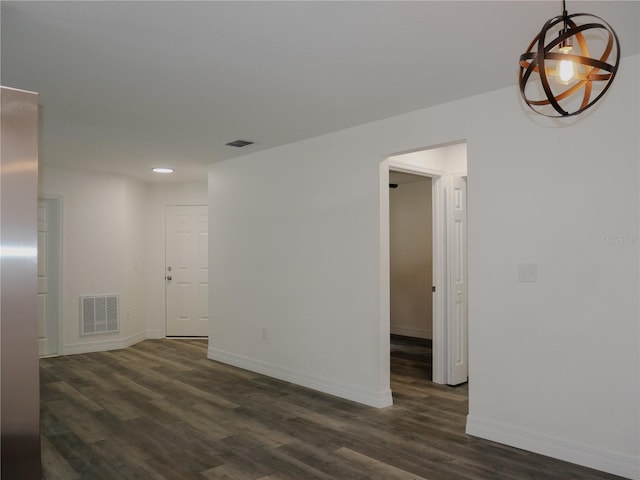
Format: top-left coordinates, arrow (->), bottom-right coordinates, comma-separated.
39,167 -> 146,354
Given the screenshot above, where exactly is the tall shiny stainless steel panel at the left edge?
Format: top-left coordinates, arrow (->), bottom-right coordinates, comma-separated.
0,88 -> 41,480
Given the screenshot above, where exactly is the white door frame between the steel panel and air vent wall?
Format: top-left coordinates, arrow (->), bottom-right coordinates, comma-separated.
38,195 -> 64,356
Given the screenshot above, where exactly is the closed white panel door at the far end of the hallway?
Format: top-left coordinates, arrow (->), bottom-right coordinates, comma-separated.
165,205 -> 209,337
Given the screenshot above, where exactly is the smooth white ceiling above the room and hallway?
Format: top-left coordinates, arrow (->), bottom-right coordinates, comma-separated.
0,0 -> 640,181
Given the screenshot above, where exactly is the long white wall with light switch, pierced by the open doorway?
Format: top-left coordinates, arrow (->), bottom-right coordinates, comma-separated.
209,56 -> 640,478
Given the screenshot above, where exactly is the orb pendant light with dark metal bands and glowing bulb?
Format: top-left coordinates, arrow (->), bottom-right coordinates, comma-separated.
519,0 -> 620,117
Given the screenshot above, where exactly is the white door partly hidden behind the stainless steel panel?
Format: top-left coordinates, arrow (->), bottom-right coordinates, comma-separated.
38,199 -> 58,356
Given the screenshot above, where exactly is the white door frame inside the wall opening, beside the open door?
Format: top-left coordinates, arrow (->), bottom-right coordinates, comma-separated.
382,159 -> 447,384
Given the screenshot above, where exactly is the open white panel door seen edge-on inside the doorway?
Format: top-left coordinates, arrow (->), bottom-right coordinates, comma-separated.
446,177 -> 469,385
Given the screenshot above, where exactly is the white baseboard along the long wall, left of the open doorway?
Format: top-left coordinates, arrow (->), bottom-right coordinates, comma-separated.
207,348 -> 393,408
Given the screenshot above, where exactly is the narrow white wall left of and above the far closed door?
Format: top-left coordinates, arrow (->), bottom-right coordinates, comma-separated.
144,181 -> 207,338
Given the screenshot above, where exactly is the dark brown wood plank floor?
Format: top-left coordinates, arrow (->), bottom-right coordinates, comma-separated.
40,338 -> 617,480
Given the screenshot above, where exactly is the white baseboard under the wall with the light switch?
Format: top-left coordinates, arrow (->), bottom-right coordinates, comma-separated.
466,415 -> 640,480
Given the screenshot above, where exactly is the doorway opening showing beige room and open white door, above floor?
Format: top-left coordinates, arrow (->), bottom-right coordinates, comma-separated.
386,143 -> 468,385
